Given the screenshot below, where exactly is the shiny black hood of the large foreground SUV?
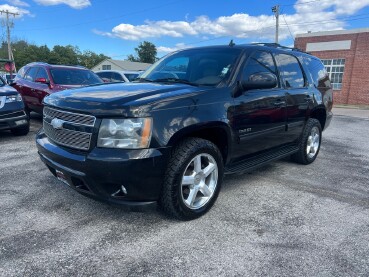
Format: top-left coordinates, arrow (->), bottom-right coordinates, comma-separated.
44,83 -> 208,116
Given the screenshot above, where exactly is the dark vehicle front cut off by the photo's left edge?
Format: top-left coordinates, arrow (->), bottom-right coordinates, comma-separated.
0,77 -> 29,136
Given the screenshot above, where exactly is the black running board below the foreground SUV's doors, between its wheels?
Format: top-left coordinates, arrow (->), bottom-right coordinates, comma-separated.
224,143 -> 299,174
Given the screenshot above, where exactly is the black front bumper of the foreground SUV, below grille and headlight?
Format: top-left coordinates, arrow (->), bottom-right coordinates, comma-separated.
36,129 -> 169,206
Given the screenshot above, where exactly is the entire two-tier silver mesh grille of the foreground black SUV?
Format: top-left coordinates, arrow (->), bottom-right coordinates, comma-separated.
43,107 -> 96,150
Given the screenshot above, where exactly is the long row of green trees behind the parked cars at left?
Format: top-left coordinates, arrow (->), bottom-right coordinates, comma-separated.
0,40 -> 110,69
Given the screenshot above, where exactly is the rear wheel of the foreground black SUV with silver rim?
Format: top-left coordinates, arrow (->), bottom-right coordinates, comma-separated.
292,118 -> 322,165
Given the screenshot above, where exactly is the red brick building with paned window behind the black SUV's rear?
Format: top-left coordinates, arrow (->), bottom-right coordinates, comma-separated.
295,28 -> 369,105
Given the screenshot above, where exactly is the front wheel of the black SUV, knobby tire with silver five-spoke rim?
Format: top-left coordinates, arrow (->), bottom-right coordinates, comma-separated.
159,138 -> 223,220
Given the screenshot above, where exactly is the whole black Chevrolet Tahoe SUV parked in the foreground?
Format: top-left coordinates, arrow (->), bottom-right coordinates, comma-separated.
36,44 -> 332,219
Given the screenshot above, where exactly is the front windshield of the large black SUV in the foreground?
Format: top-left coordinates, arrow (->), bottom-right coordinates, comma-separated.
137,47 -> 241,86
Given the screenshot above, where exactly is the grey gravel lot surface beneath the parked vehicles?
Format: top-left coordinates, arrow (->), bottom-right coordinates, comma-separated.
0,111 -> 369,276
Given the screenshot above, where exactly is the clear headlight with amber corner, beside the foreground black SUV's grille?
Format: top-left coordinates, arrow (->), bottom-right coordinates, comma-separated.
97,118 -> 152,149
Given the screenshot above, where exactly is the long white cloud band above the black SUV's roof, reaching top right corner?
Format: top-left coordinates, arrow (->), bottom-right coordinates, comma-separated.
96,0 -> 369,42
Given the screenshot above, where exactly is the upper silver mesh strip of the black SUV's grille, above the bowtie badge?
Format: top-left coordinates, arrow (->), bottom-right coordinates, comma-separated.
44,107 -> 96,127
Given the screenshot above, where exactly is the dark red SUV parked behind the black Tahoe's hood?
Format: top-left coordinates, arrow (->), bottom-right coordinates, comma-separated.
12,62 -> 103,114
